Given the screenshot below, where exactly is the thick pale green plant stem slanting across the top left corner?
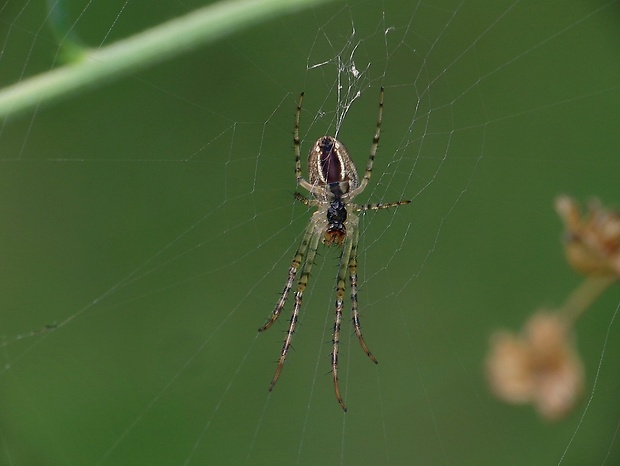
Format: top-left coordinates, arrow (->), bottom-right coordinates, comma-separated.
0,0 -> 334,118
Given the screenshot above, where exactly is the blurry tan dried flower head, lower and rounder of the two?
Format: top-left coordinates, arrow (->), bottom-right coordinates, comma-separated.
486,312 -> 584,420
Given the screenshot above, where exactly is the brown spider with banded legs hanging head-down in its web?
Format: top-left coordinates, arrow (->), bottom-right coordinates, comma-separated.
258,88 -> 411,412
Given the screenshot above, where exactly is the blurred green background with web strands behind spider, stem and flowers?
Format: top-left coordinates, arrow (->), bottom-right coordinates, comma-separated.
0,0 -> 620,465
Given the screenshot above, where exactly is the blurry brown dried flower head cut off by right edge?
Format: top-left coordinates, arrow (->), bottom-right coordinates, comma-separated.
555,196 -> 620,276
